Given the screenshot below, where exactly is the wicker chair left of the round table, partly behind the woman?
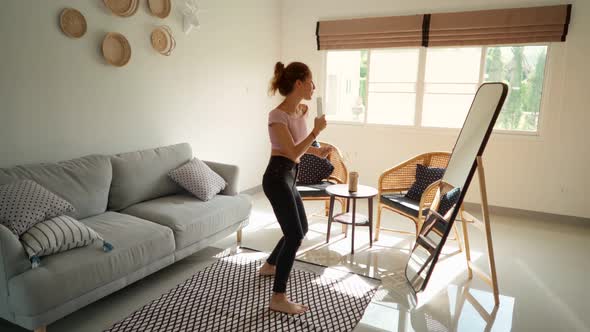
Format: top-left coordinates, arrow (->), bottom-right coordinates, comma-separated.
299,142 -> 348,216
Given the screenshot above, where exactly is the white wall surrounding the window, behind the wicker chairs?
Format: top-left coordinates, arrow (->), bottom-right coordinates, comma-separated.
281,0 -> 590,218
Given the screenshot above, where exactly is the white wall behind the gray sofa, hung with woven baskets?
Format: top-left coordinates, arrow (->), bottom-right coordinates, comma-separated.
0,0 -> 280,189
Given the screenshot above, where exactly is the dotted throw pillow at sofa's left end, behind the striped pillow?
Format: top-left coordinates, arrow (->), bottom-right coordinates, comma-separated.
0,180 -> 74,236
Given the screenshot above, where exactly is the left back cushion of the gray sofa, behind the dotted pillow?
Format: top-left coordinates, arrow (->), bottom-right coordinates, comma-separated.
0,155 -> 112,220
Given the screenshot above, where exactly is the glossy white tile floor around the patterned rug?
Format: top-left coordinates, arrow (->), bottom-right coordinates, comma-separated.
0,193 -> 590,332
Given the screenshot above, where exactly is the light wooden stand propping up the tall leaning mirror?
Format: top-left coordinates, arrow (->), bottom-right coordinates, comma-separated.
459,156 -> 500,306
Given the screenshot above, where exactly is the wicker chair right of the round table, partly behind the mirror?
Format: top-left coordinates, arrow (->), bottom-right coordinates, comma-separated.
375,152 -> 451,241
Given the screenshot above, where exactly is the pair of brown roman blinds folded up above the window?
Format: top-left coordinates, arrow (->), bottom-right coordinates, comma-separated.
316,5 -> 572,50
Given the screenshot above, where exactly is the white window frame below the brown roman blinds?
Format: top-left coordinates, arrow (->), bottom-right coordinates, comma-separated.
321,43 -> 553,136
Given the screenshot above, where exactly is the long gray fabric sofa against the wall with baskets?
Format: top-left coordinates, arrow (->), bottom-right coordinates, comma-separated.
0,143 -> 252,331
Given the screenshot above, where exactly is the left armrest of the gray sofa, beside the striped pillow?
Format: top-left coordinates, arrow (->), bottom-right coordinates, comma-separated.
0,225 -> 31,312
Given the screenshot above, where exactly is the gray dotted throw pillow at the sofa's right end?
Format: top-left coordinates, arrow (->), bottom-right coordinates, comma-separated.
168,158 -> 227,201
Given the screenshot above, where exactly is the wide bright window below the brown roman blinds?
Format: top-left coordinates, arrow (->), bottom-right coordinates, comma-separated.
325,45 -> 547,132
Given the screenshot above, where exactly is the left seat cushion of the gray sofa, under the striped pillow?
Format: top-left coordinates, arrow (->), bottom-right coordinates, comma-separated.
8,212 -> 175,316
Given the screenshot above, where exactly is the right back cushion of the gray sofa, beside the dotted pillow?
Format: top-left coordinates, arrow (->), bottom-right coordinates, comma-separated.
108,143 -> 192,211
